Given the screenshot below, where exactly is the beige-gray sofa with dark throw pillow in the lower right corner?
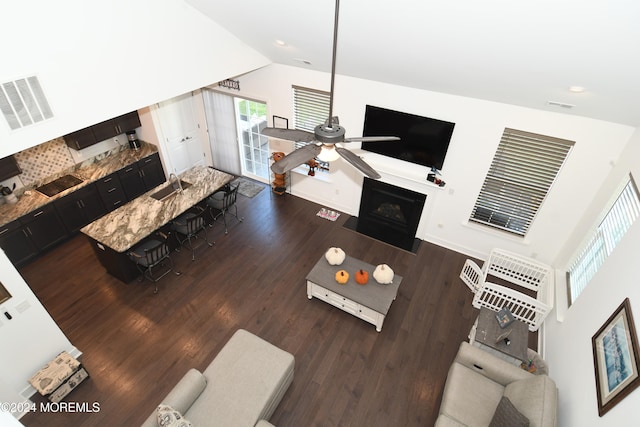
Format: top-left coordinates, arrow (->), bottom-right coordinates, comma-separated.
435,342 -> 558,427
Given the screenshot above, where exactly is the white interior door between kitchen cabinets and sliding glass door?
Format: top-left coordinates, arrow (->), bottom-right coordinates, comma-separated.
156,93 -> 206,175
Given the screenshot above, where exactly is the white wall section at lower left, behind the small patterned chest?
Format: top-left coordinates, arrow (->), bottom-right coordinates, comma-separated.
0,250 -> 80,415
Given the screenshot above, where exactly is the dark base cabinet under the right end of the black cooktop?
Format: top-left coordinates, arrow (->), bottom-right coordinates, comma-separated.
54,183 -> 107,233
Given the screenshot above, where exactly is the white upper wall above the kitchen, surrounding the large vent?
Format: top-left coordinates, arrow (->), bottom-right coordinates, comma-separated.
0,0 -> 269,157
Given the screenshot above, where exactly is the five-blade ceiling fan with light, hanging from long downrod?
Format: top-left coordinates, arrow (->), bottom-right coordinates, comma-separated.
262,0 -> 400,179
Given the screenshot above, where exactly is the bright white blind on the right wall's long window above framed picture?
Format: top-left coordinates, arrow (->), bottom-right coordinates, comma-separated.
568,177 -> 640,303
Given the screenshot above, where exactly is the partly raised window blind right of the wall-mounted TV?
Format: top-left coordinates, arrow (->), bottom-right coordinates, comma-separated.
470,128 -> 573,236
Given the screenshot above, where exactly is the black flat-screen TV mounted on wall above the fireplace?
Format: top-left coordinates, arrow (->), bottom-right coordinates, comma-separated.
362,105 -> 455,169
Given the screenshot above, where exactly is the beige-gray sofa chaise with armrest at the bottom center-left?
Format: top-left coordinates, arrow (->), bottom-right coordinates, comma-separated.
143,329 -> 294,427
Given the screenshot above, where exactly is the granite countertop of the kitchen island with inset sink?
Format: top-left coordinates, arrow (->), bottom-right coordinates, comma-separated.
80,166 -> 235,252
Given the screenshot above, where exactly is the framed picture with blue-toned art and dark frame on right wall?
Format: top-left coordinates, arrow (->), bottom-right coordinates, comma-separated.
591,298 -> 640,416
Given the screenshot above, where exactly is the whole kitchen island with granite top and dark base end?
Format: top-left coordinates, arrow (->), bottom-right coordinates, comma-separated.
80,166 -> 235,282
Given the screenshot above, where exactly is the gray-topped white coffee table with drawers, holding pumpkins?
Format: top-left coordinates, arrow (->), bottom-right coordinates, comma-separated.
307,256 -> 402,332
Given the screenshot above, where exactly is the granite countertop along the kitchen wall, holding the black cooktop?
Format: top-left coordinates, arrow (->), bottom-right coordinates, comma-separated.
0,143 -> 158,226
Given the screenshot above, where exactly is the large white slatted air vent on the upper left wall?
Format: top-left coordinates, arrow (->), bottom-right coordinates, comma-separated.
0,76 -> 53,130
